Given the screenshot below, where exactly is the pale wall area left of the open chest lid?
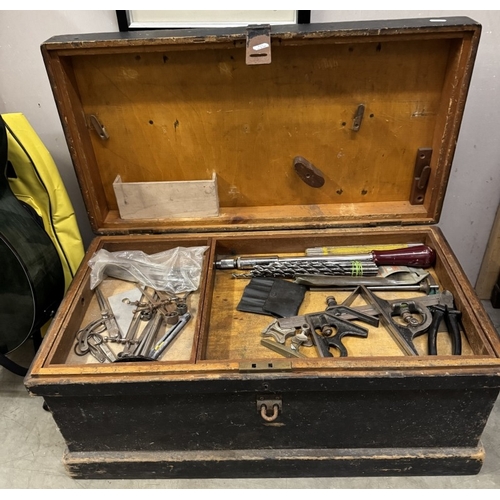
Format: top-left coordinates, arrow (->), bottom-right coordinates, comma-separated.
0,10 -> 118,246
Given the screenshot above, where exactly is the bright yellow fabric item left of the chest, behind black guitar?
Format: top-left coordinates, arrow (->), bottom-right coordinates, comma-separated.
2,113 -> 84,290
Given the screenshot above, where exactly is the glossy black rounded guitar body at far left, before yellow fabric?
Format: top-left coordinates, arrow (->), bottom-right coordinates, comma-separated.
0,117 -> 65,375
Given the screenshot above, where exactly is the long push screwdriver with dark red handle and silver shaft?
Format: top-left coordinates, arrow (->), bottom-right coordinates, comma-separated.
215,245 -> 436,269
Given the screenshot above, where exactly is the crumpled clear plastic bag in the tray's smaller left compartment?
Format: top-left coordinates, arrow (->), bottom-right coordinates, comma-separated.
89,246 -> 208,294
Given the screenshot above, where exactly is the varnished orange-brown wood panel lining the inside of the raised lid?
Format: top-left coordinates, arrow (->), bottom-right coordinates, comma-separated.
74,40 -> 450,208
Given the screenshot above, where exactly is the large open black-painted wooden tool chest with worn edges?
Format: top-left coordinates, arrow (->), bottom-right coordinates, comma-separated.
25,17 -> 500,478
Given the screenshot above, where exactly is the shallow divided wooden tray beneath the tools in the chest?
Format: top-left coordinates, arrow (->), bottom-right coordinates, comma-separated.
34,227 -> 500,364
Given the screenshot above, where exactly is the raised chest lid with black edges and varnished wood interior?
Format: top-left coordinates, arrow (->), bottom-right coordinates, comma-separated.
42,17 -> 480,234
